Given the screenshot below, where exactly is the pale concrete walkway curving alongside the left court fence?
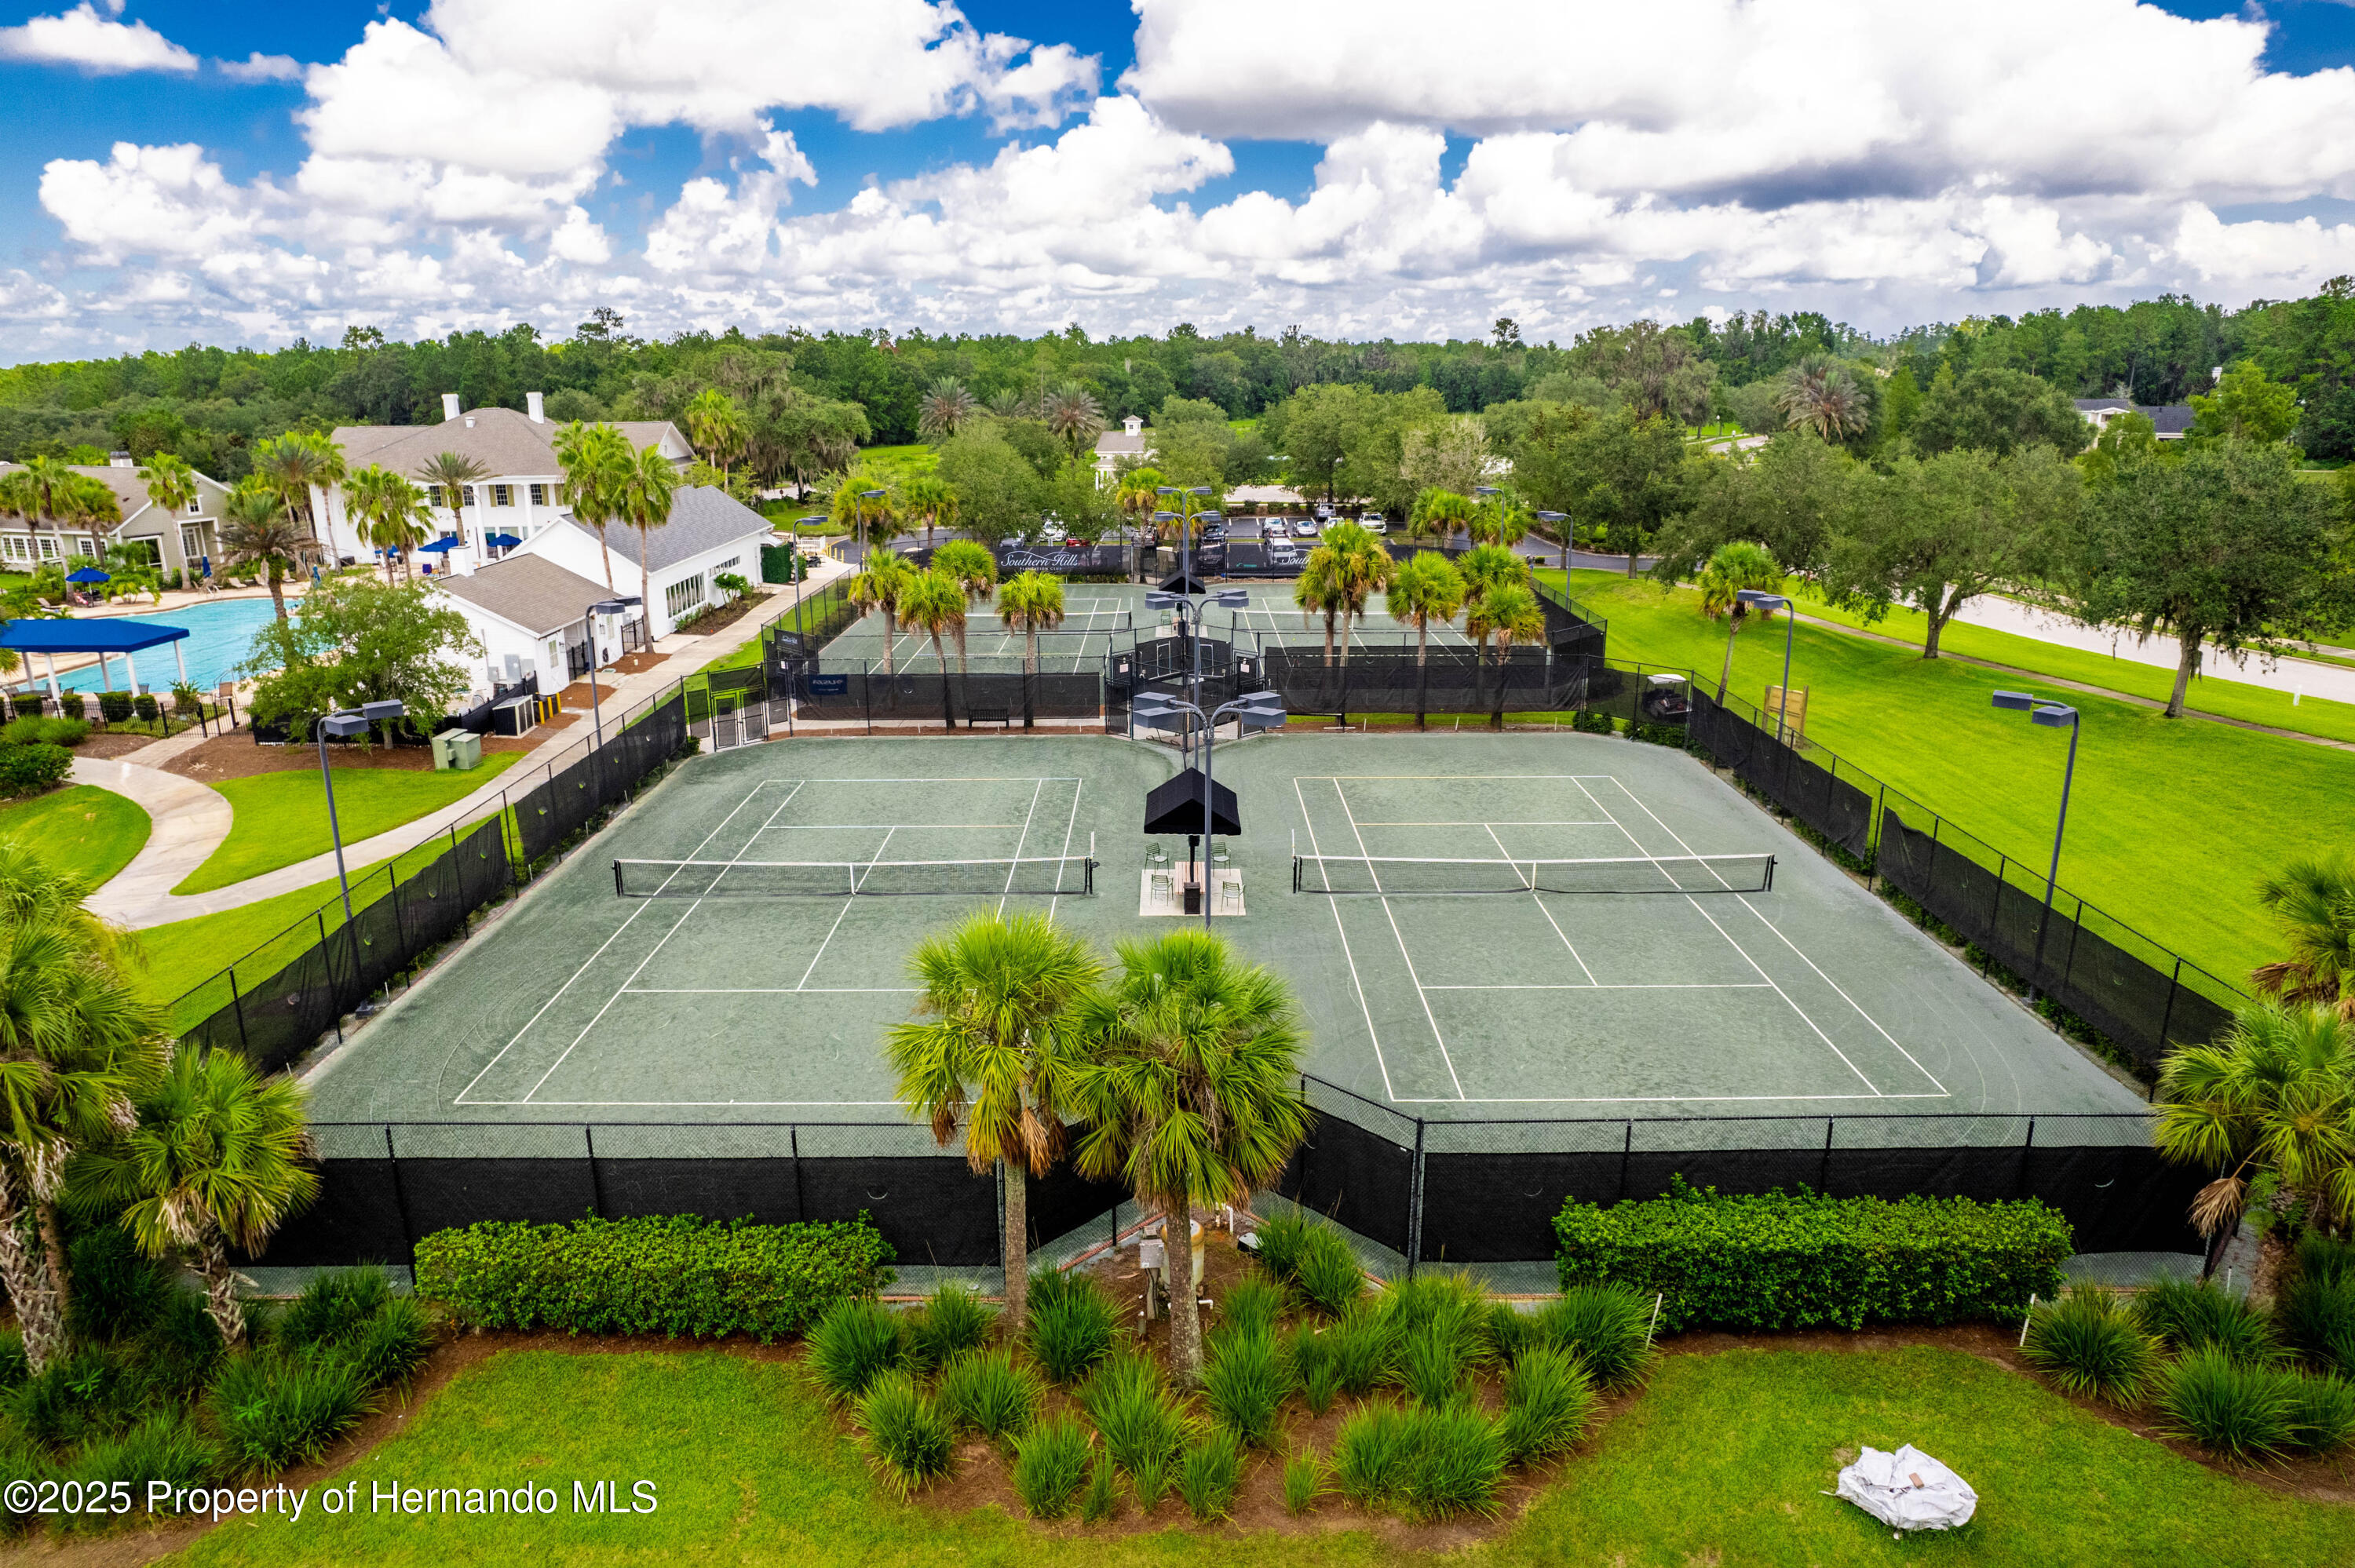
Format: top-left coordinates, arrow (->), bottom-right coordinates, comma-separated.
87,560 -> 850,930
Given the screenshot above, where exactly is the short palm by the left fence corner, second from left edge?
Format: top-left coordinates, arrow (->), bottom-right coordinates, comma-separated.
73,1050 -> 318,1349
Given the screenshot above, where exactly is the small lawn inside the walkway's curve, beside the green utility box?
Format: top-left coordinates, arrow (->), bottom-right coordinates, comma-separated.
172,751 -> 523,892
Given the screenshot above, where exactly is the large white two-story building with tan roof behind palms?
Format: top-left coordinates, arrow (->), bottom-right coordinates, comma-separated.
311,393 -> 695,572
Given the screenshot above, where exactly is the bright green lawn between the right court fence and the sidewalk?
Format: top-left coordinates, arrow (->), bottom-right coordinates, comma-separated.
1545,572 -> 2355,984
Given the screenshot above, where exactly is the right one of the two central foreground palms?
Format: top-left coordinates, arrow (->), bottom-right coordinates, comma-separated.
1069,930 -> 1309,1387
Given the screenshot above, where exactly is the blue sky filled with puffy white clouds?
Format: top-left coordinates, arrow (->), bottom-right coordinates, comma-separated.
0,0 -> 2355,360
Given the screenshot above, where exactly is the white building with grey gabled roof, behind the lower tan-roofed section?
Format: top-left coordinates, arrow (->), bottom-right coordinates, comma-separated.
516,485 -> 775,640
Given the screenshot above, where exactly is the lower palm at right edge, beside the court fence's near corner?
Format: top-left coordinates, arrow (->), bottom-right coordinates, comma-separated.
2152,998 -> 2355,1262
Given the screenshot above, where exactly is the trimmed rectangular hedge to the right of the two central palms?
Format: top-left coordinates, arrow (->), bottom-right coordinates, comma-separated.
1554,1177 -> 2075,1330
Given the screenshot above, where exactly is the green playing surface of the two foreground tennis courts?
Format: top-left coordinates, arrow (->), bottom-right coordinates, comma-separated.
313,735 -> 2141,1123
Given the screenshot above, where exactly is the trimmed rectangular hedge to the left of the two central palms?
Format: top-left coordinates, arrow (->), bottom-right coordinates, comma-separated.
417,1215 -> 893,1344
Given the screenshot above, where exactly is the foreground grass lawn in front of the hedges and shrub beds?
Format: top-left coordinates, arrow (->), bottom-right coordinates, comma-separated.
170,1349 -> 2355,1568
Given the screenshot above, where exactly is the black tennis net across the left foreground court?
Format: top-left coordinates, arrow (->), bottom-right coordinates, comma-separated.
612,855 -> 1095,899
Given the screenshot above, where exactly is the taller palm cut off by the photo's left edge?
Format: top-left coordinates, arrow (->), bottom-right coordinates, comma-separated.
0,838 -> 160,1370
